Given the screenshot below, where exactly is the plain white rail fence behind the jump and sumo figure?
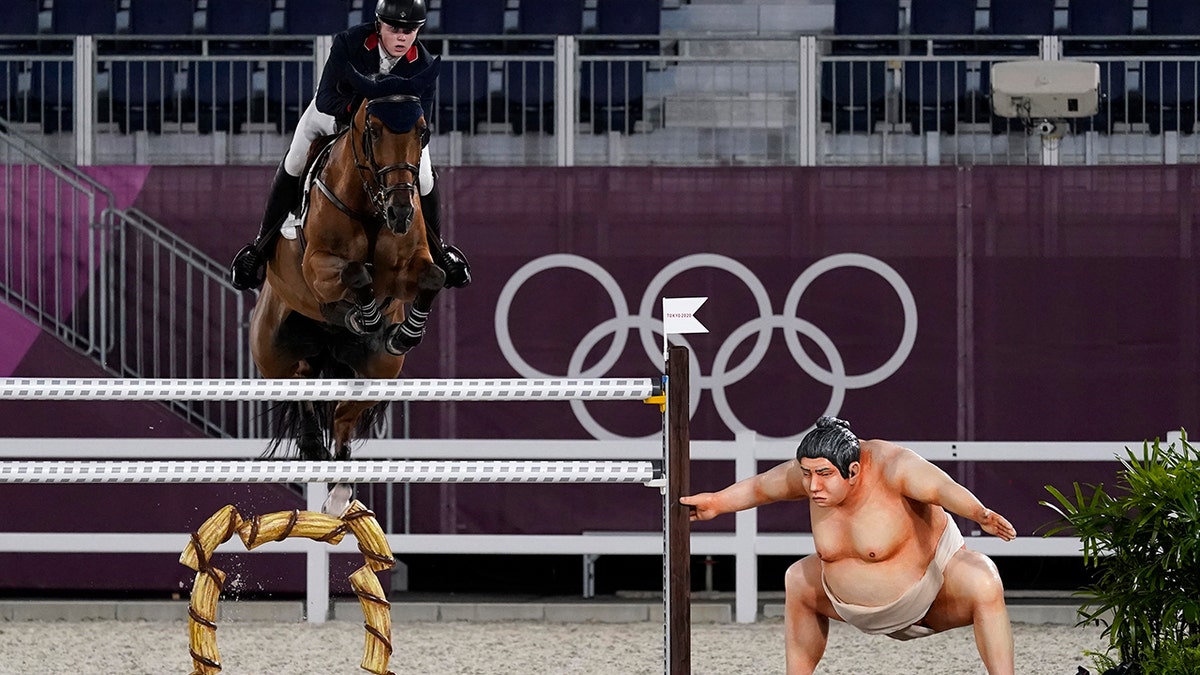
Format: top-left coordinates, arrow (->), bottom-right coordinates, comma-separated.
0,434 -> 1132,622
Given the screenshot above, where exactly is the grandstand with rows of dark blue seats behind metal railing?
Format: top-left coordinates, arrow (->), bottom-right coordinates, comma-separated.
0,0 -> 1200,166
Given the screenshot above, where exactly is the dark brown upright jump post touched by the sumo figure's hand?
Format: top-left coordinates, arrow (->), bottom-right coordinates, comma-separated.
662,346 -> 691,675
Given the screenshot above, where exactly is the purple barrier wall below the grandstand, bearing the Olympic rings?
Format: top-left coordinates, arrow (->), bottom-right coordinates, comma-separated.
0,167 -> 1200,590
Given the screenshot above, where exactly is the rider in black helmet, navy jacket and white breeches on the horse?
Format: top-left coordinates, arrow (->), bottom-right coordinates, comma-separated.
230,0 -> 470,291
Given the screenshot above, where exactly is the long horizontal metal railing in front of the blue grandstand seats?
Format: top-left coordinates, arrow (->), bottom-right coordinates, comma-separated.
0,35 -> 1200,166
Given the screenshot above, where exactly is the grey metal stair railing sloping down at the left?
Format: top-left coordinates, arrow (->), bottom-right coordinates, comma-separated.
0,117 -> 250,436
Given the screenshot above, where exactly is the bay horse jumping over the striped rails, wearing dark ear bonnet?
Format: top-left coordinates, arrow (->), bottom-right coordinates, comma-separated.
250,61 -> 445,515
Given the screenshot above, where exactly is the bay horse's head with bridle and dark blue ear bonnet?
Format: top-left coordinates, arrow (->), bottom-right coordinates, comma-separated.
354,60 -> 439,235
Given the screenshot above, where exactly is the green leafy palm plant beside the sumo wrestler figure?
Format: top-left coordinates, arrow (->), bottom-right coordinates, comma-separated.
1040,432 -> 1200,675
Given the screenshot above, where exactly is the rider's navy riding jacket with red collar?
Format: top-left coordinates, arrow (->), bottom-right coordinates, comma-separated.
317,23 -> 437,125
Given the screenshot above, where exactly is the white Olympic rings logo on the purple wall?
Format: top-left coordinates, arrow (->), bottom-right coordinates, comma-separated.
496,253 -> 917,441
